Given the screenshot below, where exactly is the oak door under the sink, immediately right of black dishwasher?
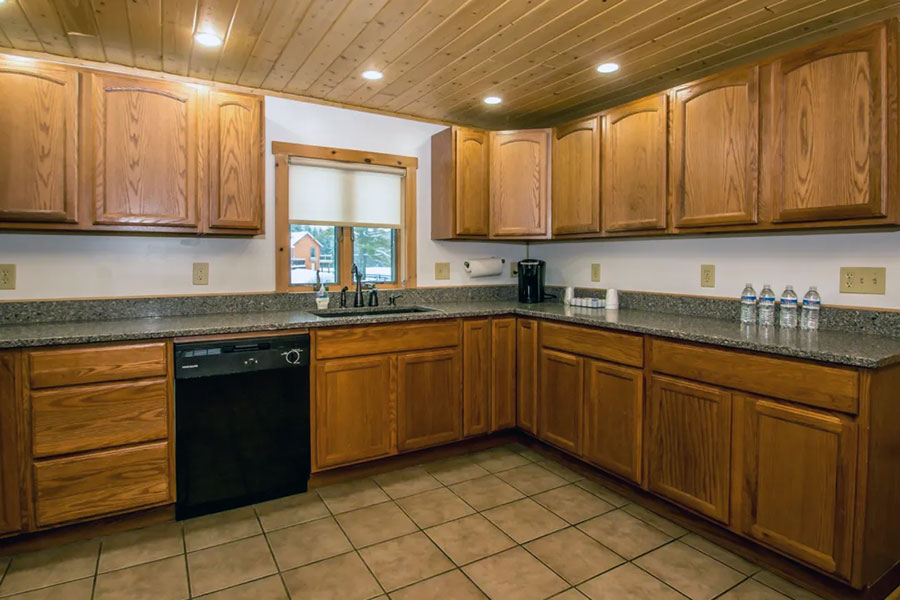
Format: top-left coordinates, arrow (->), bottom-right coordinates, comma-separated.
313,356 -> 395,469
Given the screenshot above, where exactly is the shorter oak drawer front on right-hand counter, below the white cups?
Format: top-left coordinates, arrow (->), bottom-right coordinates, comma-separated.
541,323 -> 644,367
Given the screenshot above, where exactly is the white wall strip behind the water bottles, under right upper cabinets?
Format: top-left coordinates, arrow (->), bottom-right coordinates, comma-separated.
531,232 -> 900,308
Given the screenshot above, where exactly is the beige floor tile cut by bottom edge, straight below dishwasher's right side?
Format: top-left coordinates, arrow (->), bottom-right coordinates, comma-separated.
283,552 -> 386,600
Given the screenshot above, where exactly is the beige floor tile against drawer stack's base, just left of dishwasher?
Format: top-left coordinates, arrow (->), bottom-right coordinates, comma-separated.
97,523 -> 184,573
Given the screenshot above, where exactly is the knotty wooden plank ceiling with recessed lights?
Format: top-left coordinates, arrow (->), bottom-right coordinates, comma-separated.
0,0 -> 900,129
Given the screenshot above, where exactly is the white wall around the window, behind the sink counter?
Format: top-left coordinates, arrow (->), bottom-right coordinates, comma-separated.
0,98 -> 525,300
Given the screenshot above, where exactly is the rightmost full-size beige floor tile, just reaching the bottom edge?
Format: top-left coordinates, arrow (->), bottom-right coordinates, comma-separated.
634,542 -> 745,600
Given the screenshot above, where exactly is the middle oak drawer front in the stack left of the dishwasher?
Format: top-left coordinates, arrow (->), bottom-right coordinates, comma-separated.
31,379 -> 169,457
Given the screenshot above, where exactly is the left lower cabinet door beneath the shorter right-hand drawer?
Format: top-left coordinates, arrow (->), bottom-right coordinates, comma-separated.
538,348 -> 584,454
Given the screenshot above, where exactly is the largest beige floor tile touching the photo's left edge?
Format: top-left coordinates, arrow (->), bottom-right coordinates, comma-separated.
0,539 -> 100,596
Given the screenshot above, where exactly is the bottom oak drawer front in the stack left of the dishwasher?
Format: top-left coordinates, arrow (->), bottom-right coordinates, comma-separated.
34,442 -> 170,527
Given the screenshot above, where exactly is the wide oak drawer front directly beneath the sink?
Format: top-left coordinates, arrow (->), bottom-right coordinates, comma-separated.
316,319 -> 459,359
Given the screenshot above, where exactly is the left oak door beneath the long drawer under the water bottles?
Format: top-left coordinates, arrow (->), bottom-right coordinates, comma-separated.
647,377 -> 731,524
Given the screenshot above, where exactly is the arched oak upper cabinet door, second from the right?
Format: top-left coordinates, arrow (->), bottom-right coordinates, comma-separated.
669,66 -> 759,228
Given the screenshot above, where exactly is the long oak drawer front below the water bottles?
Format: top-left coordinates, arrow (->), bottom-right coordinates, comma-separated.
652,339 -> 859,414
